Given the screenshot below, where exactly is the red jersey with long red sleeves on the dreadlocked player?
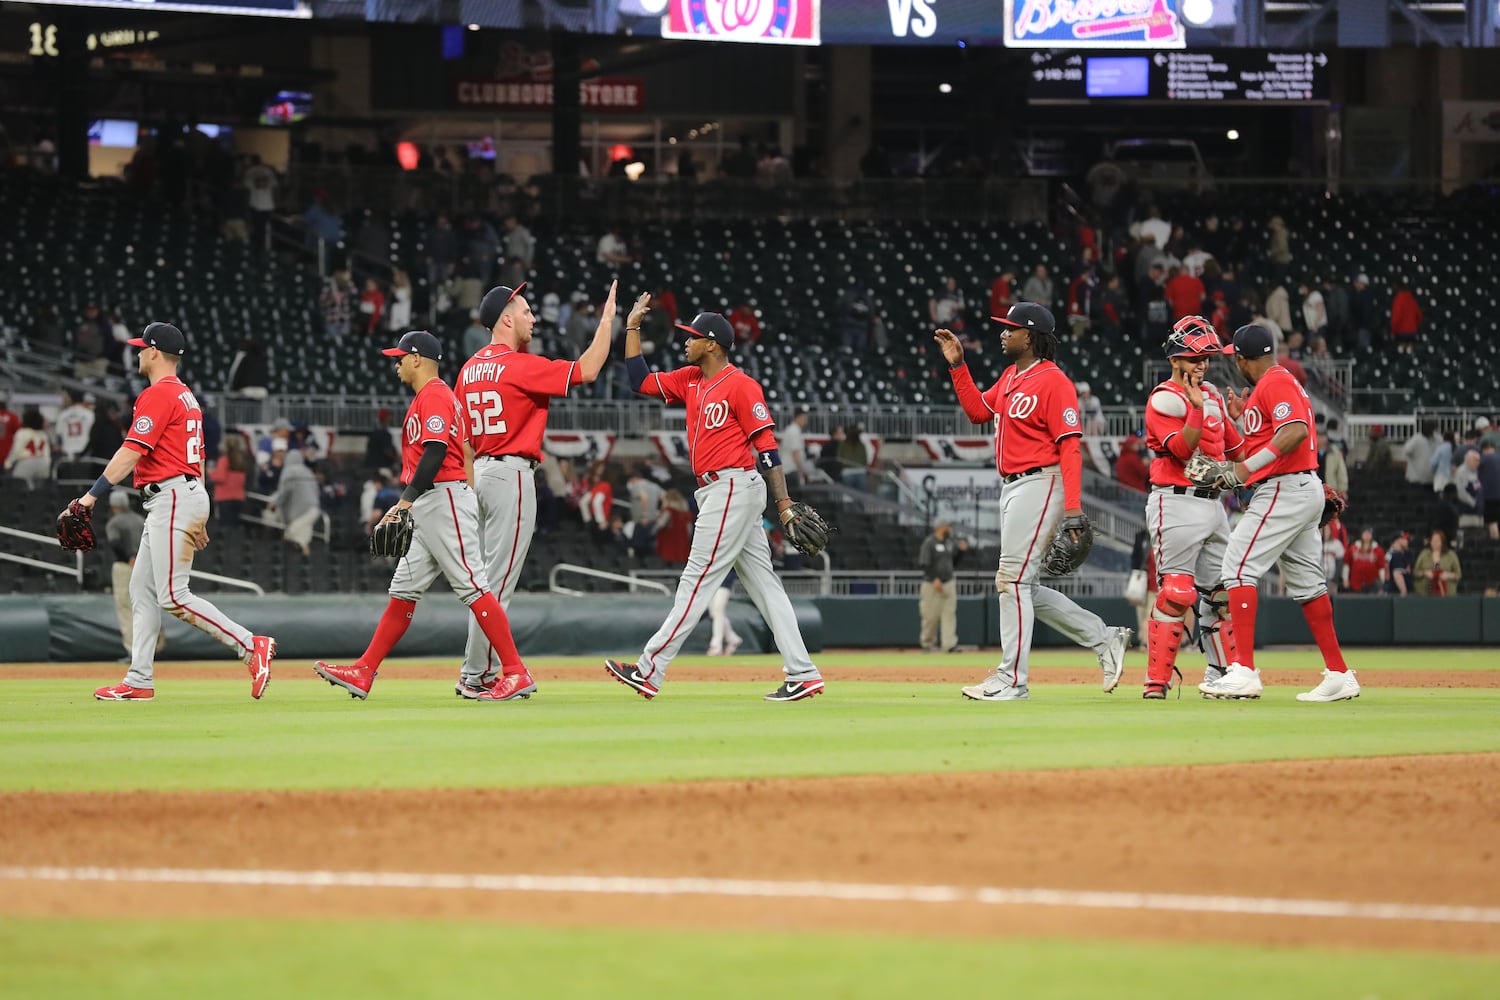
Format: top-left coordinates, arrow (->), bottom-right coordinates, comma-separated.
954,361 -> 1083,475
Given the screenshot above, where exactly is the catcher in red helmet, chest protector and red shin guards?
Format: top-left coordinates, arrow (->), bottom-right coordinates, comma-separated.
1142,316 -> 1244,700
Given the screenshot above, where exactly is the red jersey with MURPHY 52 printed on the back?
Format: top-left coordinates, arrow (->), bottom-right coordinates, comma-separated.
456,343 -> 582,462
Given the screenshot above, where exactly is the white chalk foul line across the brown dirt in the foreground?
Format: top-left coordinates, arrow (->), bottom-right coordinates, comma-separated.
0,865 -> 1500,924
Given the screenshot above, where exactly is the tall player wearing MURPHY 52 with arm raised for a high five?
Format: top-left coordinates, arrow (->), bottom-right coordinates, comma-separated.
453,275 -> 618,700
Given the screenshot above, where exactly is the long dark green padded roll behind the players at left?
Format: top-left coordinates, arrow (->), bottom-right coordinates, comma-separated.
0,594 -> 824,670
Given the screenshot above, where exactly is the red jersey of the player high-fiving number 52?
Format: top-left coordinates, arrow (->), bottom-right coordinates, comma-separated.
641,364 -> 776,475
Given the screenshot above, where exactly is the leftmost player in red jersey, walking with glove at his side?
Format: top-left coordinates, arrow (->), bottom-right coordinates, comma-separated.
67,322 -> 276,702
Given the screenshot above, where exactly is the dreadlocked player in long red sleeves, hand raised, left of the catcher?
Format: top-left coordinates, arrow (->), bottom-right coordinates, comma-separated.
933,303 -> 1134,702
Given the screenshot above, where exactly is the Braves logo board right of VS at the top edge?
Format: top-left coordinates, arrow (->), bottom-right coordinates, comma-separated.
1005,0 -> 1187,48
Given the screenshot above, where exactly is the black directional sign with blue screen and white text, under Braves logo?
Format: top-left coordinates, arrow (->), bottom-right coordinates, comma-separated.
1026,49 -> 1332,103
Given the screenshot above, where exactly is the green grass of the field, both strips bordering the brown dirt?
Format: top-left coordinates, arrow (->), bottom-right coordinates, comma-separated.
0,649 -> 1500,1000
